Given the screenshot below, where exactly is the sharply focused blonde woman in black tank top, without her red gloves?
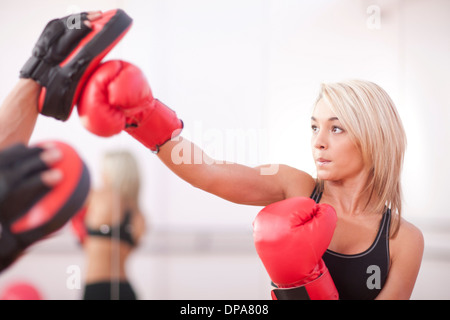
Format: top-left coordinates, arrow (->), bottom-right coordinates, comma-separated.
154,80 -> 424,299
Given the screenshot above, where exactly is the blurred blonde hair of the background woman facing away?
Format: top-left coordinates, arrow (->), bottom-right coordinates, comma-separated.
102,151 -> 140,205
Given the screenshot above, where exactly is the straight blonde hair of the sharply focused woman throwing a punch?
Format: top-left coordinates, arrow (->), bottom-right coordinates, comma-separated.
316,80 -> 406,237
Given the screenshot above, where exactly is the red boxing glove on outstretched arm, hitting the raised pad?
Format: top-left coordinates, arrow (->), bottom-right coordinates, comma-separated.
78,60 -> 183,152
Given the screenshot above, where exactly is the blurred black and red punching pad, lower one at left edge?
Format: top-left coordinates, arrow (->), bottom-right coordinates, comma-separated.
0,142 -> 90,271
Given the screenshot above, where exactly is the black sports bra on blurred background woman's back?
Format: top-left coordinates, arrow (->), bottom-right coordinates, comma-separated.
86,210 -> 136,247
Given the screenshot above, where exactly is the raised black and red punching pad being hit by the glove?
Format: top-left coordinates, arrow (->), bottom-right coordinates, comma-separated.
20,9 -> 132,121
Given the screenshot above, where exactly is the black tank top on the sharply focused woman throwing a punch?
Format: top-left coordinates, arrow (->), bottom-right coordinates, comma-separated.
311,187 -> 391,300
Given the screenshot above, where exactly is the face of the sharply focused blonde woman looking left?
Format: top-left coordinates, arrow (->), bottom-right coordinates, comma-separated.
311,99 -> 364,181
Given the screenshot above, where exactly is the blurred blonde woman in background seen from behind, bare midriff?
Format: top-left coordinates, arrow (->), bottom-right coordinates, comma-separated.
83,151 -> 145,300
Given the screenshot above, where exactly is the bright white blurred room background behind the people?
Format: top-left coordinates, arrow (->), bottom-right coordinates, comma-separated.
0,0 -> 450,299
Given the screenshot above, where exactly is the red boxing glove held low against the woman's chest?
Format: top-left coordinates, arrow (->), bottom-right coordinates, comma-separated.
253,197 -> 338,300
